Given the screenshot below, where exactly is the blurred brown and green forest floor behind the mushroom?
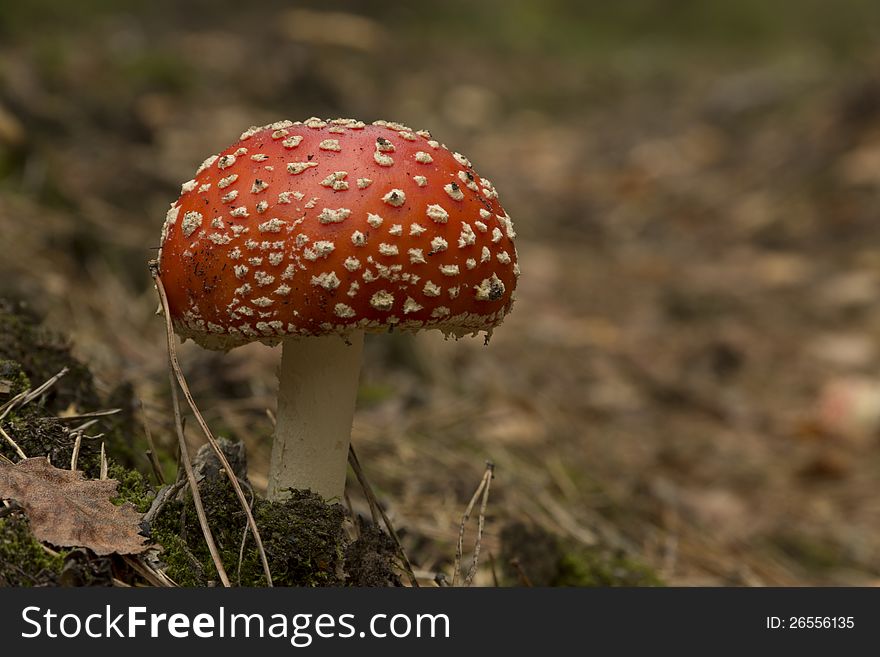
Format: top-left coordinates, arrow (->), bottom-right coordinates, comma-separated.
0,0 -> 880,585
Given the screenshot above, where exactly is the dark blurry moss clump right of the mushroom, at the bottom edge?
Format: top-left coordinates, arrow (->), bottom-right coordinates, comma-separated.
501,523 -> 664,586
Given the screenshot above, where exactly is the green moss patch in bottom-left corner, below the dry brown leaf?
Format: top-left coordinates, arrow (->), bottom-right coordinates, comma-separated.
0,512 -> 64,586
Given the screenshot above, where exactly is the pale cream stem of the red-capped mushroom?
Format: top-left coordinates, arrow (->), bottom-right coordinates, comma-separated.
268,331 -> 364,500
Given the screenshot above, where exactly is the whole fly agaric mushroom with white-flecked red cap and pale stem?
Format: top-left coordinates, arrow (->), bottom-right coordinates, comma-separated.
159,118 -> 519,499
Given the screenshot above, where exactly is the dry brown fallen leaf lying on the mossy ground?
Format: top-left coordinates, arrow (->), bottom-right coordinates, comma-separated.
0,457 -> 149,555
